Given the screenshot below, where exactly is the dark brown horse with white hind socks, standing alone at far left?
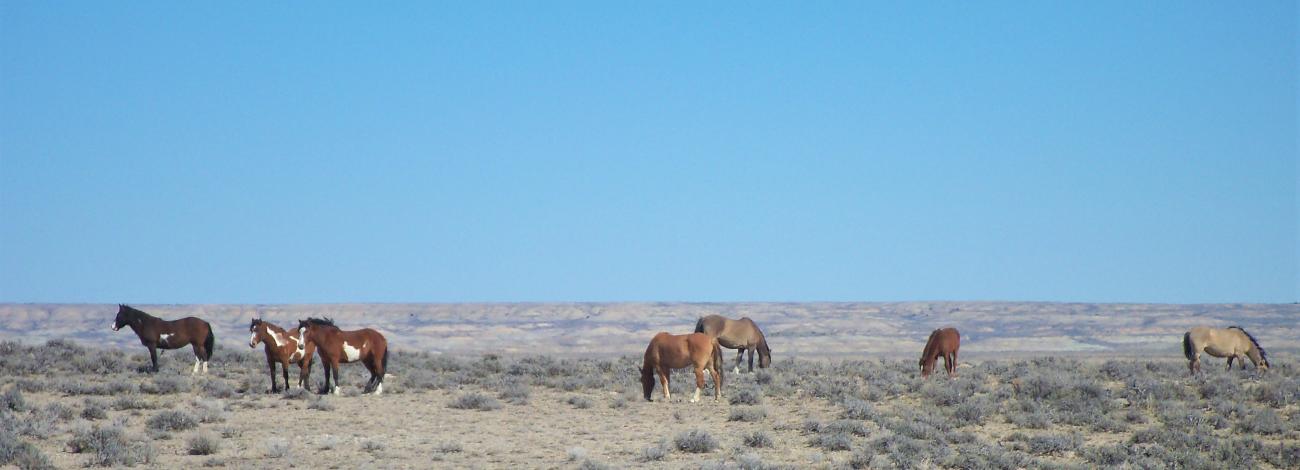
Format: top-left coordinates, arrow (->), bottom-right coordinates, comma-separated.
113,304 -> 216,375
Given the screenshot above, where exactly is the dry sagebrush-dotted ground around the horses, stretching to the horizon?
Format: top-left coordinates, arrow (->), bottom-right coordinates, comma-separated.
0,304 -> 1300,469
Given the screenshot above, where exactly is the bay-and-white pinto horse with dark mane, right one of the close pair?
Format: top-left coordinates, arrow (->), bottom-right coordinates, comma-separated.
298,318 -> 389,395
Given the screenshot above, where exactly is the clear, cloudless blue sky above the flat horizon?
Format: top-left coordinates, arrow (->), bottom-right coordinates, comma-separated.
0,1 -> 1300,303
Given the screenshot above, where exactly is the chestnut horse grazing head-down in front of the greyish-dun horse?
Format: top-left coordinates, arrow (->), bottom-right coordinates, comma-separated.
641,331 -> 723,402
